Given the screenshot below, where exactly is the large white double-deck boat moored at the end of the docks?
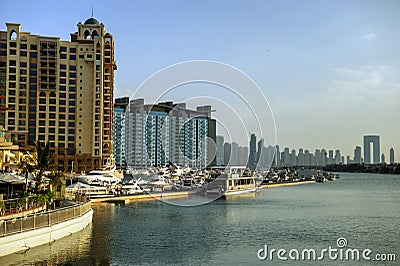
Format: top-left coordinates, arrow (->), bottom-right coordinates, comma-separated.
205,166 -> 258,198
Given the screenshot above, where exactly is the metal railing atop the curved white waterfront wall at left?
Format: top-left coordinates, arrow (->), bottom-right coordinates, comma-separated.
0,202 -> 91,237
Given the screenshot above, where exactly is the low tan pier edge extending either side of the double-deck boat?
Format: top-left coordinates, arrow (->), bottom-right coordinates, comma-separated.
90,180 -> 316,204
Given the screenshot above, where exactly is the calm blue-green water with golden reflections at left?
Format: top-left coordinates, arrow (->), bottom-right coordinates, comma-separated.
0,173 -> 400,265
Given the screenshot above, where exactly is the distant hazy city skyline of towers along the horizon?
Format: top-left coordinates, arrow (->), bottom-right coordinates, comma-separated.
216,133 -> 398,168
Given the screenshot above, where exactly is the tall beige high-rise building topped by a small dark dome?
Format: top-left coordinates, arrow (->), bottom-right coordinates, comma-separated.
0,17 -> 117,171
